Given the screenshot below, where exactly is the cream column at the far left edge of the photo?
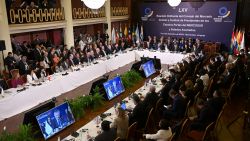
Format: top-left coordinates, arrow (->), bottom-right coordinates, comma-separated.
0,0 -> 12,70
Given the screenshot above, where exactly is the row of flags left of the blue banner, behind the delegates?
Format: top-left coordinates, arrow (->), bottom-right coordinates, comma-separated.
111,24 -> 144,44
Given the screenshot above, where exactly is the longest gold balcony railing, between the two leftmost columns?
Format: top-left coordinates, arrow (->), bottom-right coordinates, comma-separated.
9,8 -> 65,24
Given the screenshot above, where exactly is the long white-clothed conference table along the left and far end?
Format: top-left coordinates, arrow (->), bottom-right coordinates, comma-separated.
0,50 -> 185,121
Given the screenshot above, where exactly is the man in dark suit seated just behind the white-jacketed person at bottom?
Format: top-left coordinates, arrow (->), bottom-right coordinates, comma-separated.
163,90 -> 186,119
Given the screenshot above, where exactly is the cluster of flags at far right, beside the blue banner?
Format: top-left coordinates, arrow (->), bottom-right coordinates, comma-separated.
230,29 -> 245,55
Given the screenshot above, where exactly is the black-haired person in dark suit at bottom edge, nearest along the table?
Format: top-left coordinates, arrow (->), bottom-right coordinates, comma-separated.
95,120 -> 116,141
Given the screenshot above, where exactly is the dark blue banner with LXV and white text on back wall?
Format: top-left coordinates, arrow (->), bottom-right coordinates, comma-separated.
140,1 -> 237,47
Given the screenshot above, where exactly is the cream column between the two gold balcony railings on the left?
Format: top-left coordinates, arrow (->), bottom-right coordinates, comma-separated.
61,0 -> 74,48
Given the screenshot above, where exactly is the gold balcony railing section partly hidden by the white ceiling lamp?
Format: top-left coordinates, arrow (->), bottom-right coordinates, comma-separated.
72,7 -> 105,19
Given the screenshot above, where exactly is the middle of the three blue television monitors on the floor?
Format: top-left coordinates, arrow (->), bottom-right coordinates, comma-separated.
103,76 -> 125,100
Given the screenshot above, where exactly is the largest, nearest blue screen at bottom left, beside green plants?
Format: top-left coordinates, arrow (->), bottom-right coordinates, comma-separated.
36,102 -> 75,140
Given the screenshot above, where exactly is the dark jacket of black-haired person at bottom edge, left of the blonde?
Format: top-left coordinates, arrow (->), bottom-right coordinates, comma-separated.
95,129 -> 116,141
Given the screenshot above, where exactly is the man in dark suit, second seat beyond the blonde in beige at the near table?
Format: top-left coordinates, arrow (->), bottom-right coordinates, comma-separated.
143,85 -> 159,112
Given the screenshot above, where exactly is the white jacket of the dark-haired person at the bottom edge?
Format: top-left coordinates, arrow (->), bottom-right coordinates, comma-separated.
146,128 -> 172,141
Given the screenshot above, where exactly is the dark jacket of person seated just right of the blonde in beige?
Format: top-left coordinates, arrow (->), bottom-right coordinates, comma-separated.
129,102 -> 147,128
